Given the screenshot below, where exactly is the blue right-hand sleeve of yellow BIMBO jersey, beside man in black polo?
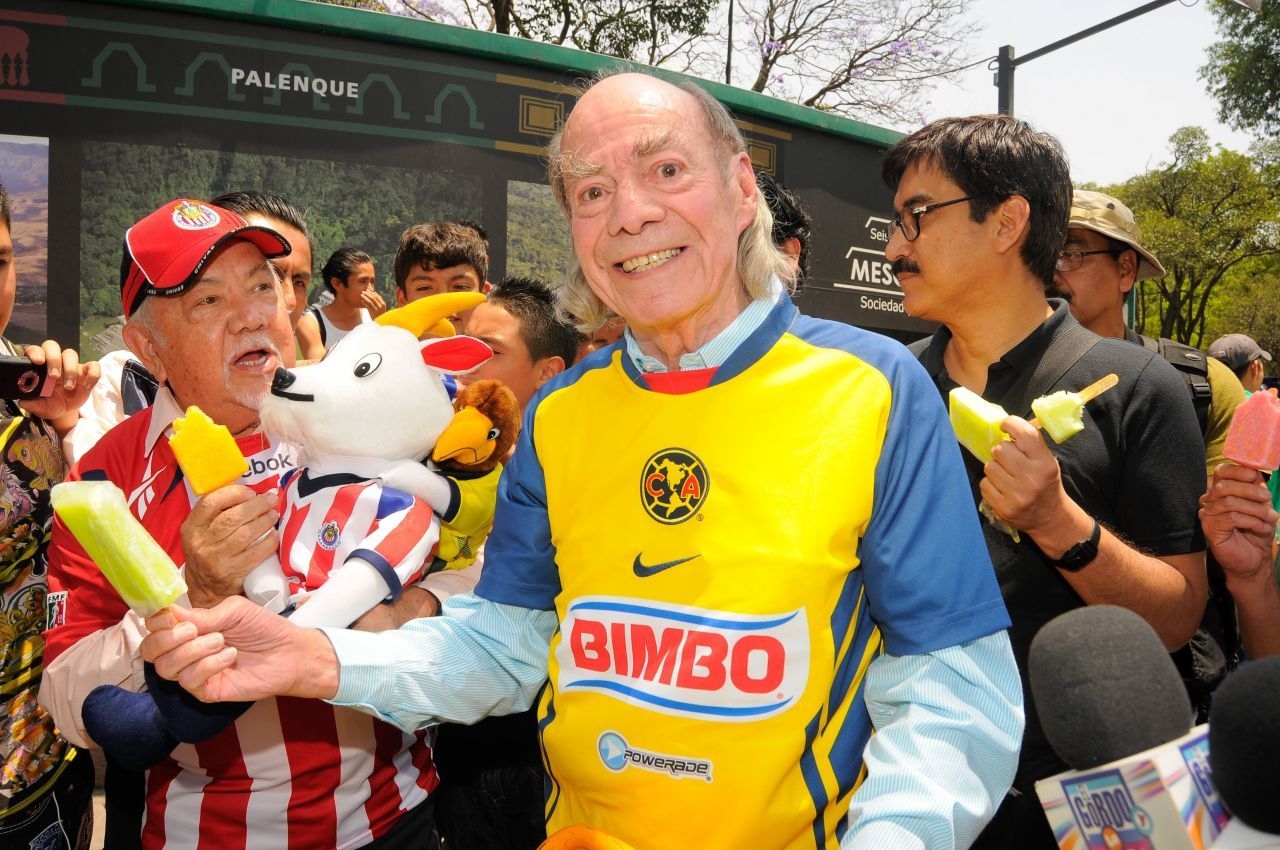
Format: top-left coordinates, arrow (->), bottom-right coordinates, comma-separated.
859,344 -> 1009,655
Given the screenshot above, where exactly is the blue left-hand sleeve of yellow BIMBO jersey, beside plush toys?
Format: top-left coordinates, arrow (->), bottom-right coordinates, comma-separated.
475,393 -> 561,611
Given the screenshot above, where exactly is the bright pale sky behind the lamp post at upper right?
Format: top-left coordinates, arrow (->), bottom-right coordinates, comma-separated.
921,0 -> 1259,186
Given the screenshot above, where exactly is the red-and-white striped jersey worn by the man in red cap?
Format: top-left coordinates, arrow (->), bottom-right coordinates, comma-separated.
46,390 -> 439,850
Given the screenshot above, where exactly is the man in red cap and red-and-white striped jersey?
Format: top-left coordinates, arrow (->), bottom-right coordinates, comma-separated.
41,198 -> 448,850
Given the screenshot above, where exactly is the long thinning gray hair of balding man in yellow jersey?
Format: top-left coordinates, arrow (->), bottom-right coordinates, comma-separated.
547,67 -> 795,333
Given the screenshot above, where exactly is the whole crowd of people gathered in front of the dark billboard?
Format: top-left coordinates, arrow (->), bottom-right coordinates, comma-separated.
0,73 -> 1280,850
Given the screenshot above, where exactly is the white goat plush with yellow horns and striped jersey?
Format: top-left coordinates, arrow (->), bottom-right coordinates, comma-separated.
244,292 -> 493,626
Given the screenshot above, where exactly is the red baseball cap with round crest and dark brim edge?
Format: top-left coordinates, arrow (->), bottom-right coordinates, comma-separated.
120,198 -> 292,319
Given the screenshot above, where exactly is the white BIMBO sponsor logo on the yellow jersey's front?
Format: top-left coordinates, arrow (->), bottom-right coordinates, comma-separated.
556,597 -> 809,721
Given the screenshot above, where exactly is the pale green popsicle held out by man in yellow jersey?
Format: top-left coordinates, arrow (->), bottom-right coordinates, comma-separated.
50,481 -> 187,617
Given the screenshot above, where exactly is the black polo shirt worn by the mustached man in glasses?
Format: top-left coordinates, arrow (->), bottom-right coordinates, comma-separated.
920,300 -> 1206,792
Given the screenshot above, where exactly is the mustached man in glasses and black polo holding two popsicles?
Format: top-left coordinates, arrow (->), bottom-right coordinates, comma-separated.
883,115 -> 1206,850
